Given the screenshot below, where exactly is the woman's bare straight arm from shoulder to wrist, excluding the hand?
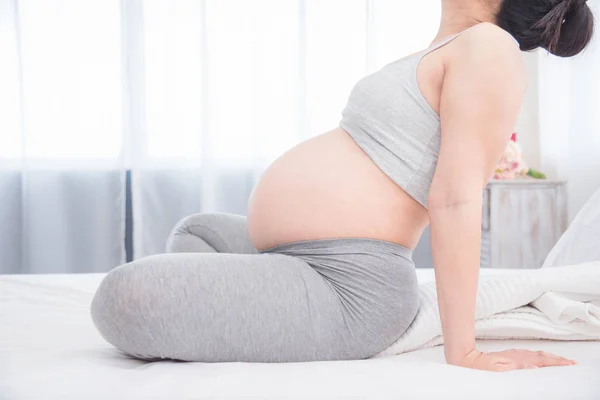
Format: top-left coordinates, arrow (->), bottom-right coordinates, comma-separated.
429,27 -> 525,365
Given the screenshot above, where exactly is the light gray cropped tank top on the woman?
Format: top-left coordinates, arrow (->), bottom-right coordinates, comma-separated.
340,31 -> 466,208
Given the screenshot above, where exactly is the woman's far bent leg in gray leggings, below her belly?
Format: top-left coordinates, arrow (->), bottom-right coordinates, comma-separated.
167,213 -> 257,254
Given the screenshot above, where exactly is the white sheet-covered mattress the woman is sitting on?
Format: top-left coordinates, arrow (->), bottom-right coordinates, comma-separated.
0,270 -> 600,400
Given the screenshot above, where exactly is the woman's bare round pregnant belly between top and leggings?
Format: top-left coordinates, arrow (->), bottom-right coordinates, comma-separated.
248,128 -> 428,250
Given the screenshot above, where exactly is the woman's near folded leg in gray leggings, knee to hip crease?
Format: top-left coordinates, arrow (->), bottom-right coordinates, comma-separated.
92,254 -> 352,362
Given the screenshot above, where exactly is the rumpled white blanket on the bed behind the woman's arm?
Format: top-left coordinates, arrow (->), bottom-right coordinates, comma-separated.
376,262 -> 600,357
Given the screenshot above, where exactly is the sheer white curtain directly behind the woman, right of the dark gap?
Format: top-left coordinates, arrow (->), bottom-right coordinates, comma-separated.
134,0 -> 440,256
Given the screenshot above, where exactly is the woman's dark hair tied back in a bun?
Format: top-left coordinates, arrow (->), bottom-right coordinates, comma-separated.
496,0 -> 594,57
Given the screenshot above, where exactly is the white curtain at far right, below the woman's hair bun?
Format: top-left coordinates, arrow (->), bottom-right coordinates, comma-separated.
538,0 -> 600,220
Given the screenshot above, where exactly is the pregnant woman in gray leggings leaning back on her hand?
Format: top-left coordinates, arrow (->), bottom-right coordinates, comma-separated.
91,0 -> 593,371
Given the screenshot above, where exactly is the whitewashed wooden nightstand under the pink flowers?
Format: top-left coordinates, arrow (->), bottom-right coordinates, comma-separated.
481,178 -> 567,268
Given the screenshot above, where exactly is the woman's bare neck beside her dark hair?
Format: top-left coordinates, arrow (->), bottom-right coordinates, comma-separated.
434,0 -> 499,42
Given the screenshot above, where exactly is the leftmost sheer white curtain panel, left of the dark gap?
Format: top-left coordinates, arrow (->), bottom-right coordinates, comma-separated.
0,0 -> 124,273
